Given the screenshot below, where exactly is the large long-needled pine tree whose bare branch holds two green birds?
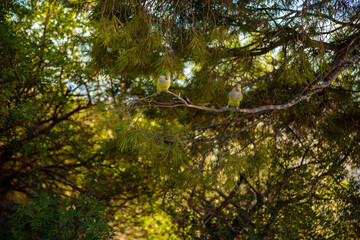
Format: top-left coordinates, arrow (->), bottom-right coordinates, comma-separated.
92,0 -> 360,239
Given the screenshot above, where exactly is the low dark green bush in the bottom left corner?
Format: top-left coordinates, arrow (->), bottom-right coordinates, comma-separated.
0,193 -> 112,240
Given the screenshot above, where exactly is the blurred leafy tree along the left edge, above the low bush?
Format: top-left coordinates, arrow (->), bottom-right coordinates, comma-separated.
0,1 -> 107,212
